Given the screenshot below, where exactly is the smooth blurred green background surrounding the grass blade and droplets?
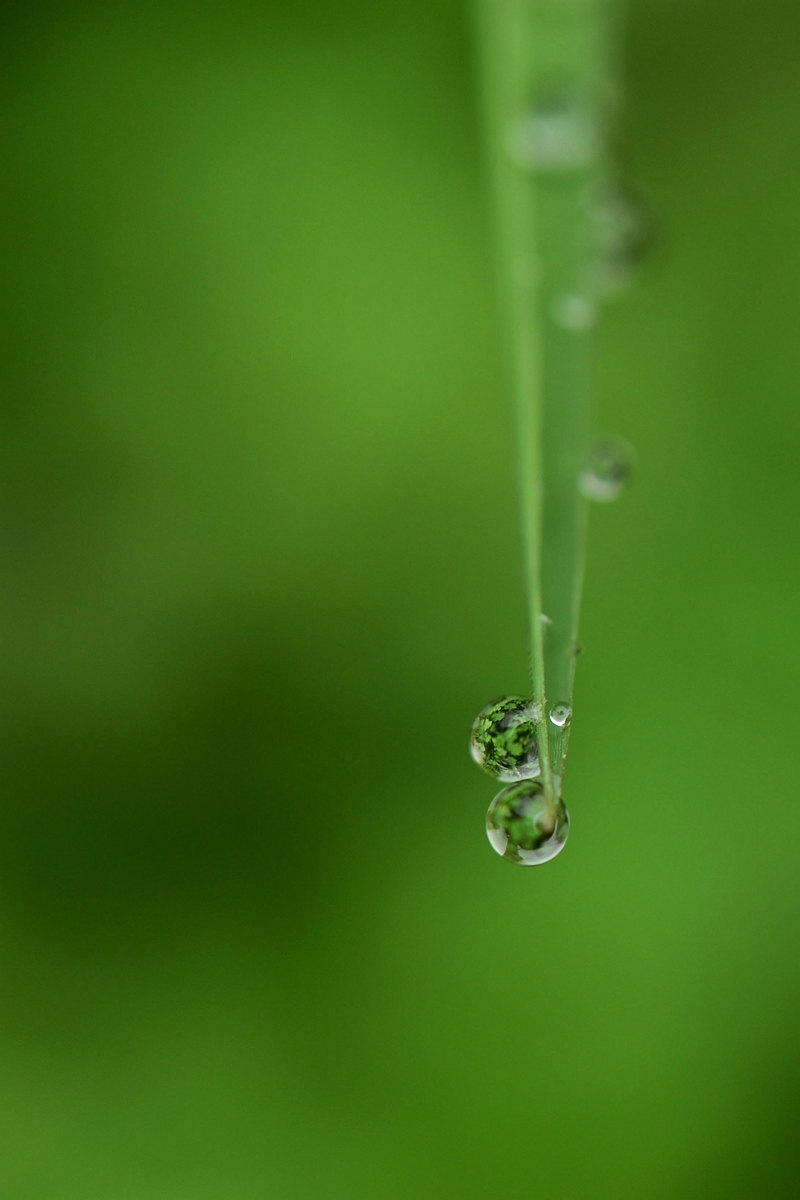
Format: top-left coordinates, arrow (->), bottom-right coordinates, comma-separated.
0,0 -> 800,1200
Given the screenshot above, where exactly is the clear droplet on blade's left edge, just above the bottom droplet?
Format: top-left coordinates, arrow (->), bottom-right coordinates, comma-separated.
469,696 -> 541,782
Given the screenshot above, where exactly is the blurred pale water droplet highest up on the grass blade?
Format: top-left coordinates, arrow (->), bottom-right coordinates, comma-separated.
506,95 -> 600,173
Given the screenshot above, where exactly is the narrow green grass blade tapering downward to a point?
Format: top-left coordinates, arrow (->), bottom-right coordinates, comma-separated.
477,0 -> 603,805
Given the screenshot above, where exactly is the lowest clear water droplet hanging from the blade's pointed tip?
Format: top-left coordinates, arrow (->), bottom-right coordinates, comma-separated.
486,779 -> 570,866
